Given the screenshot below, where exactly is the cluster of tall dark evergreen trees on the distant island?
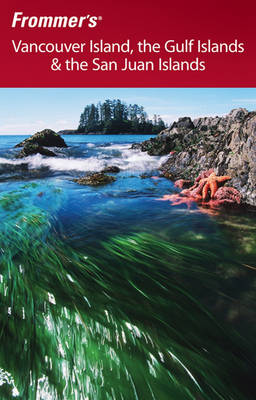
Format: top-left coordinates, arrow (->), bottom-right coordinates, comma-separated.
77,99 -> 166,134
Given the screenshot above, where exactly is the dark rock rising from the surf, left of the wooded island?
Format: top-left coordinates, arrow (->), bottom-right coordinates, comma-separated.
15,129 -> 67,147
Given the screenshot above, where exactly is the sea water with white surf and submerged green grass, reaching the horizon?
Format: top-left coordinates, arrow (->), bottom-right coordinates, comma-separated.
0,135 -> 256,400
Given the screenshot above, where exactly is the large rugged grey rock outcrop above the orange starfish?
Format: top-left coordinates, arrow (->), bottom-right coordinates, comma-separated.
137,108 -> 256,206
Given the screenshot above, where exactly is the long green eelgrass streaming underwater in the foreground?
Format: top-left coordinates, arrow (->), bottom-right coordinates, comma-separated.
0,186 -> 255,400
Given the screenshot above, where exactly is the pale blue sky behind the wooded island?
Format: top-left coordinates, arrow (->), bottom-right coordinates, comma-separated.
0,88 -> 256,135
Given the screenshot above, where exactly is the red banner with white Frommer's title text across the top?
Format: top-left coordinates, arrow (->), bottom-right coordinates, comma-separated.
0,0 -> 256,87
